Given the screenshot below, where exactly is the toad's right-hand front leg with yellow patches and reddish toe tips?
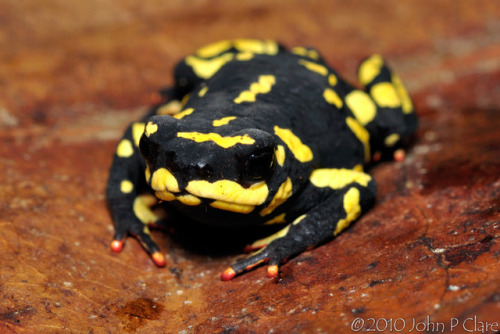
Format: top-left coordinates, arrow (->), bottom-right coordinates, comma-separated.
221,169 -> 376,280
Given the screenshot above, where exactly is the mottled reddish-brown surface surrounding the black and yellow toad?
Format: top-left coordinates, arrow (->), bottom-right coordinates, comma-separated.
0,0 -> 500,333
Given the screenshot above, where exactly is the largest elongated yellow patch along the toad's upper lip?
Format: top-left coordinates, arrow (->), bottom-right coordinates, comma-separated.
186,180 -> 269,205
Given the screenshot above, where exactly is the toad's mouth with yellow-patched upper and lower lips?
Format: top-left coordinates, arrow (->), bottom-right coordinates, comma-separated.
146,168 -> 269,213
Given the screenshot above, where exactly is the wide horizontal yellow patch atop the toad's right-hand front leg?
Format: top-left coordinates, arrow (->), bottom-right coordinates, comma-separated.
309,168 -> 372,190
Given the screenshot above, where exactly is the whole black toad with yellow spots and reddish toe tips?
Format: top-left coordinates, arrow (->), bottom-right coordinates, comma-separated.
107,40 -> 417,280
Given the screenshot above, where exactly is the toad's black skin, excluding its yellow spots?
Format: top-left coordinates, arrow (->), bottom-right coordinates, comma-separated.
107,41 -> 417,280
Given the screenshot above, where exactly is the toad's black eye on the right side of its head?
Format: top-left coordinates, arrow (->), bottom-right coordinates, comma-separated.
241,147 -> 274,182
